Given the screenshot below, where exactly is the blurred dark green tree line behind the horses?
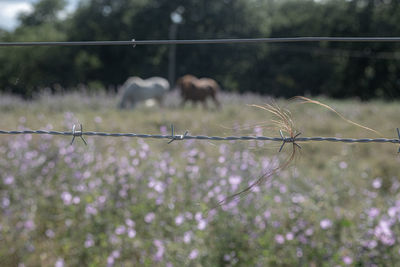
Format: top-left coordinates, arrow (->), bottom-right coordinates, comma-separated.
0,0 -> 400,100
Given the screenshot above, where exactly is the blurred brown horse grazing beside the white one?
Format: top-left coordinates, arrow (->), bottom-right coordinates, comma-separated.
176,74 -> 221,108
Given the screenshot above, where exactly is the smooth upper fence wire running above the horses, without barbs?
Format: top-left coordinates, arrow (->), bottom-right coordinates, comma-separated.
0,37 -> 400,47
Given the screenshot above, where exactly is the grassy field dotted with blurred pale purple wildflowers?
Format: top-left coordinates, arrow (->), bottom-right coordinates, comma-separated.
0,93 -> 400,267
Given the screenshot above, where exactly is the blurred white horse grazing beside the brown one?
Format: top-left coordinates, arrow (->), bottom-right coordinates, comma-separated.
118,76 -> 169,108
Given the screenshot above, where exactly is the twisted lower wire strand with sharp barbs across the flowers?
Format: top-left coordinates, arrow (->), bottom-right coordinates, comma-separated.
0,125 -> 400,153
